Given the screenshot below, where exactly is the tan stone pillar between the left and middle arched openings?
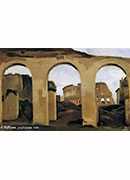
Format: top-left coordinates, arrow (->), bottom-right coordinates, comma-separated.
32,76 -> 49,125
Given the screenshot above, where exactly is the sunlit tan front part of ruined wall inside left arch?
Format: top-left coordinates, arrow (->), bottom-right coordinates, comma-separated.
2,74 -> 23,120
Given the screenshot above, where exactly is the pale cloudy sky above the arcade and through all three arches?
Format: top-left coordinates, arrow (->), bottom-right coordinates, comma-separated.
5,48 -> 130,99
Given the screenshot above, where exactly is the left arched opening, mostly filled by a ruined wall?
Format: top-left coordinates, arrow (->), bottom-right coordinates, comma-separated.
2,64 -> 33,125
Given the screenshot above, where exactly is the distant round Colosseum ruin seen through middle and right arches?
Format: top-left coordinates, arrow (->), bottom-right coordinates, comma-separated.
63,82 -> 114,106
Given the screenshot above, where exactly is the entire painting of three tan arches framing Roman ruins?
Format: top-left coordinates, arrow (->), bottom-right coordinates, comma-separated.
0,48 -> 130,131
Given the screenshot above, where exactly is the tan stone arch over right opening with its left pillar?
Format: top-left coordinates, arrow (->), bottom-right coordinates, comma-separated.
79,57 -> 130,127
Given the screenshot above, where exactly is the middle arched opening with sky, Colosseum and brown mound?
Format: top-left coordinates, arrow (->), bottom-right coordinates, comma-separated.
48,64 -> 82,127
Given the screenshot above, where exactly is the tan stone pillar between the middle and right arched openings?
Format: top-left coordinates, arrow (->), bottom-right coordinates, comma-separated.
81,73 -> 98,127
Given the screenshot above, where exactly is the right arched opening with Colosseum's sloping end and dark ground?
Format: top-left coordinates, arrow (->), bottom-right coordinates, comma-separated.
96,65 -> 128,127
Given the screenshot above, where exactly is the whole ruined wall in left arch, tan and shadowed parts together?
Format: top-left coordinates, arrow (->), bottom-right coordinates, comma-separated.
3,74 -> 32,120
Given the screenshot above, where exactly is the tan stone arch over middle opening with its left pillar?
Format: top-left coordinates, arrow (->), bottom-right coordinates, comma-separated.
32,58 -> 86,125
